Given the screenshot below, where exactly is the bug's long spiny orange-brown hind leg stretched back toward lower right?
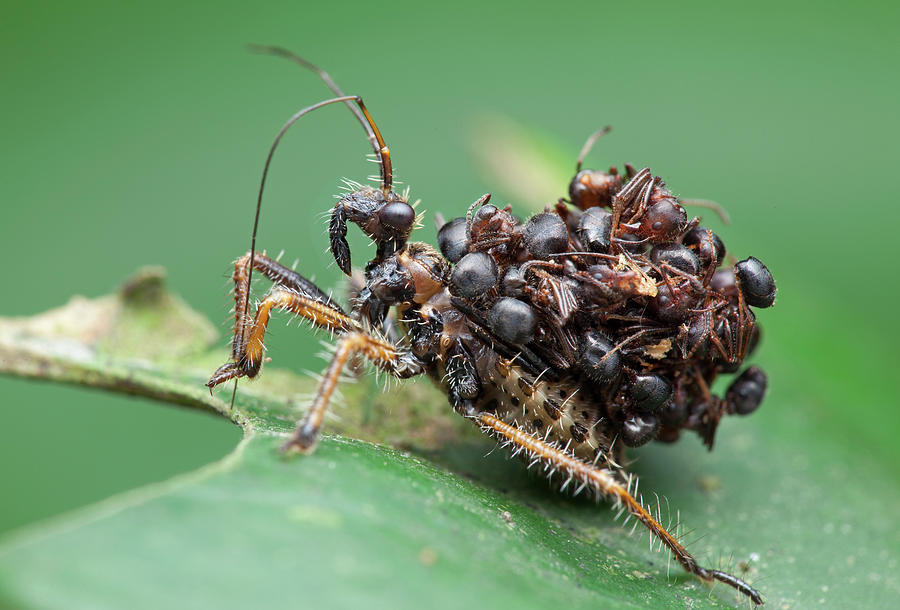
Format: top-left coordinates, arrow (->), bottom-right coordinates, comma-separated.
473,413 -> 763,606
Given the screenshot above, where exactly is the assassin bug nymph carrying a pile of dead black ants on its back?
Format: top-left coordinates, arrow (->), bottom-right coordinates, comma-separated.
207,47 -> 775,605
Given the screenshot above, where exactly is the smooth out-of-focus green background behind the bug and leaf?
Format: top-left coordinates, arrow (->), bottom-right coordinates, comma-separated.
0,1 -> 900,532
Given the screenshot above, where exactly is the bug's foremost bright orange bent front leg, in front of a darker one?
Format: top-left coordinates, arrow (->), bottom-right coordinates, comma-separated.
206,285 -> 359,390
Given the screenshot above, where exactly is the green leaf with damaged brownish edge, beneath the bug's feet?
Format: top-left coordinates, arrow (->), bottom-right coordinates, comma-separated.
0,258 -> 900,608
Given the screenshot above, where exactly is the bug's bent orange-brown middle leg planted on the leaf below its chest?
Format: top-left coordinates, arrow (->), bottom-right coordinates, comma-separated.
282,331 -> 423,453
